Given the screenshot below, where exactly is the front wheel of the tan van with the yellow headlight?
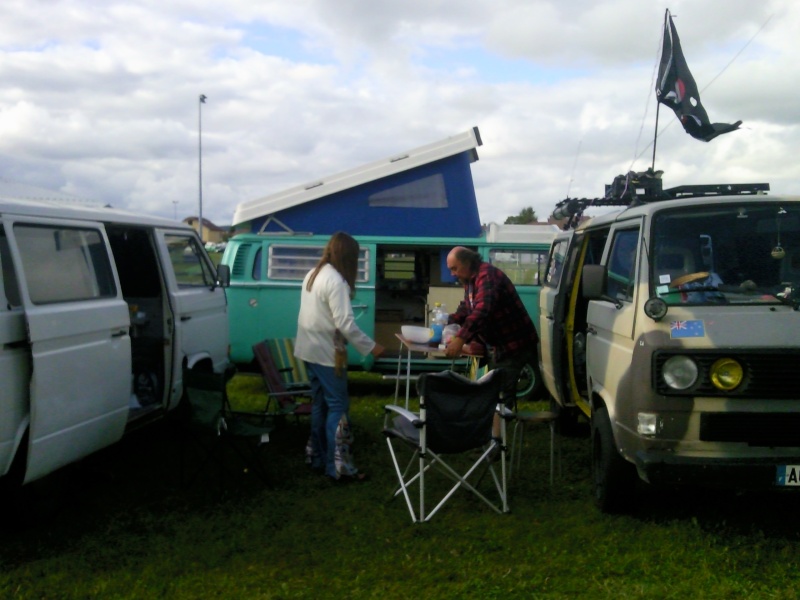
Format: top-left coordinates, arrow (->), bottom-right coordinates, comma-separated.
592,407 -> 638,513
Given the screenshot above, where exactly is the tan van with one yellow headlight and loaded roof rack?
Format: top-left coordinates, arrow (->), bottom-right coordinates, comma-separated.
540,173 -> 800,511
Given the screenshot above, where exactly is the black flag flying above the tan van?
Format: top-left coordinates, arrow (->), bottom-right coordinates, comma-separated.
656,11 -> 742,142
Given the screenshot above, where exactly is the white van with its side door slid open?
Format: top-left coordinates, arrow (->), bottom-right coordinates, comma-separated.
0,187 -> 229,485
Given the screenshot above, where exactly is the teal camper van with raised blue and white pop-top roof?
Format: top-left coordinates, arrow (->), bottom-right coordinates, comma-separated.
222,128 -> 558,371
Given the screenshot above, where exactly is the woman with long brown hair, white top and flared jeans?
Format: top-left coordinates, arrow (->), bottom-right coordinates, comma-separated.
294,231 -> 384,481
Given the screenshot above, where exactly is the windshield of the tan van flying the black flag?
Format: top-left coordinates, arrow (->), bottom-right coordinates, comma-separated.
650,204 -> 800,304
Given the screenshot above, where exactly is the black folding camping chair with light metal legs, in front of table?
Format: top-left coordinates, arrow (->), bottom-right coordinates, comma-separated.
383,369 -> 509,523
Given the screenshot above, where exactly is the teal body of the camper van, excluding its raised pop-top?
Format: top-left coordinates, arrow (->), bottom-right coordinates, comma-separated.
222,224 -> 557,378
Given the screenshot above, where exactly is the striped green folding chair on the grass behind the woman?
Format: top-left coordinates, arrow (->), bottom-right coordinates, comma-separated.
253,340 -> 312,418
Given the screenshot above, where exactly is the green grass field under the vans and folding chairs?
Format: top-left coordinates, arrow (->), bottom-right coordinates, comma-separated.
0,375 -> 800,599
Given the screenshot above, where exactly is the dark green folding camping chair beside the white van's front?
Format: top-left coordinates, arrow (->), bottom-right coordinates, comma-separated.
181,368 -> 274,492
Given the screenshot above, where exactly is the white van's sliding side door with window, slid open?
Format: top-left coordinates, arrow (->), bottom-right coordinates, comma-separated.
3,218 -> 131,482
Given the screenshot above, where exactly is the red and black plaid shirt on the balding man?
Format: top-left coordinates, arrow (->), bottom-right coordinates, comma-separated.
450,262 -> 539,360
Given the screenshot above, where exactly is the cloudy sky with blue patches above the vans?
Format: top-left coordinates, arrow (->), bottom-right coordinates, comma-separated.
0,0 -> 800,225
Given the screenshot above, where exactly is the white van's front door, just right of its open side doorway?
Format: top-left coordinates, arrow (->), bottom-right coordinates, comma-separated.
157,229 -> 229,398
